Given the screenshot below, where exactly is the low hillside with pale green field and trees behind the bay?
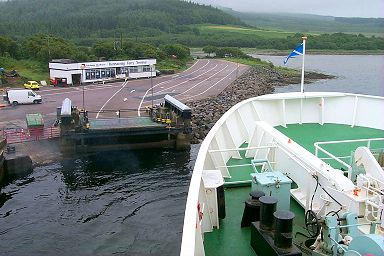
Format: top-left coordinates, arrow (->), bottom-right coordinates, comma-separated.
137,24 -> 384,51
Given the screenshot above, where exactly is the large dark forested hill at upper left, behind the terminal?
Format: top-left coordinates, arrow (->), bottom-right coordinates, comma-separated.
0,0 -> 245,39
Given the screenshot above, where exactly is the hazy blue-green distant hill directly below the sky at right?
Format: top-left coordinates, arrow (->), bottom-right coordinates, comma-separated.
220,8 -> 384,35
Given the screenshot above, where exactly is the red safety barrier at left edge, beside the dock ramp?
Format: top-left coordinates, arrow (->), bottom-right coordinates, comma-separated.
3,127 -> 60,144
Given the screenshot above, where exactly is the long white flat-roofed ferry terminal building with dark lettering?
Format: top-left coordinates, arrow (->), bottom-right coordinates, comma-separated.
49,59 -> 156,86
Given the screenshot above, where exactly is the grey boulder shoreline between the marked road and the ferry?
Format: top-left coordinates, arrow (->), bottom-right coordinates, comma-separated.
187,66 -> 334,144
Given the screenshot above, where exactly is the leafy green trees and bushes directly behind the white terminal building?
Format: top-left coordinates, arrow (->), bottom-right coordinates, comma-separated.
0,34 -> 190,63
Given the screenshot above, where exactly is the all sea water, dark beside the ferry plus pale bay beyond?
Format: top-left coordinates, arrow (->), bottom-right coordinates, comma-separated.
0,55 -> 384,255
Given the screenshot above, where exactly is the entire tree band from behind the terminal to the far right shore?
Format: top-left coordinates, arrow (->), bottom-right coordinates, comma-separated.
0,33 -> 384,69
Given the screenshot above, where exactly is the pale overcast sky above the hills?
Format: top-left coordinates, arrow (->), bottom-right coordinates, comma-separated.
192,0 -> 384,18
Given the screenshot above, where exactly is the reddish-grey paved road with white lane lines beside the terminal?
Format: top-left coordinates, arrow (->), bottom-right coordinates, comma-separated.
0,59 -> 247,129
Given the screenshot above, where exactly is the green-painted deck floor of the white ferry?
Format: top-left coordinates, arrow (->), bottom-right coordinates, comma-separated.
204,124 -> 384,256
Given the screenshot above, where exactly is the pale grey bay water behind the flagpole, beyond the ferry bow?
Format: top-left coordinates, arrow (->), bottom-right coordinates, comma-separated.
251,54 -> 384,96
